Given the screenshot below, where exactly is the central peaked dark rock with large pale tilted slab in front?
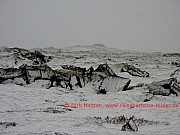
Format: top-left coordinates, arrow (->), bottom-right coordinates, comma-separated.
62,64 -> 130,94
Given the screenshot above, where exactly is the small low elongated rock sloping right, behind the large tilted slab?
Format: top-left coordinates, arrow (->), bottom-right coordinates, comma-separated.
113,63 -> 149,77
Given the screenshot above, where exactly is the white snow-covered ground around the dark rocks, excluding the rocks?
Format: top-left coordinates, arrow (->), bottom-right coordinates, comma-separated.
0,46 -> 180,135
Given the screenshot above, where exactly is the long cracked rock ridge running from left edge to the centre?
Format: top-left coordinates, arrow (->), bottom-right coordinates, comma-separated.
0,64 -> 87,89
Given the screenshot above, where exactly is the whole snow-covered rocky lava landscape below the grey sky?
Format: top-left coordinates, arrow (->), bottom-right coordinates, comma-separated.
0,44 -> 180,135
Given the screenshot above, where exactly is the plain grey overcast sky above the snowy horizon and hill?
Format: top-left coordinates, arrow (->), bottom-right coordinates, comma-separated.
0,0 -> 180,52
